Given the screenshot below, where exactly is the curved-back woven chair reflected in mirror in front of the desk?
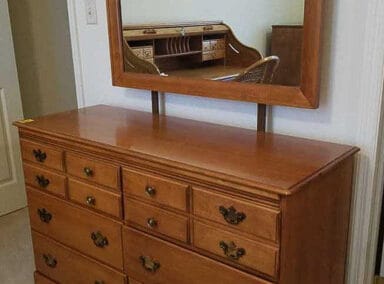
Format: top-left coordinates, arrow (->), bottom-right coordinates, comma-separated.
233,56 -> 280,84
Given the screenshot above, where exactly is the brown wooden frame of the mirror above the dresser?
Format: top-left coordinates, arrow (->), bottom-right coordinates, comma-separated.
106,0 -> 324,109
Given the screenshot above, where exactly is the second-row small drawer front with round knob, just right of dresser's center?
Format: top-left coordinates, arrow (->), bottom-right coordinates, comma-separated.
124,199 -> 188,242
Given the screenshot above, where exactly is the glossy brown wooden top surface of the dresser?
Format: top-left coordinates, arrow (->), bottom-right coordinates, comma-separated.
15,105 -> 358,194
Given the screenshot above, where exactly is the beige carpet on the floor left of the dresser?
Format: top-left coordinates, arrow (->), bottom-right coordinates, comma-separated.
0,209 -> 35,284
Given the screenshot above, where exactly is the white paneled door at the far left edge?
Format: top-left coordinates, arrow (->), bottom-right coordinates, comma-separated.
0,0 -> 26,216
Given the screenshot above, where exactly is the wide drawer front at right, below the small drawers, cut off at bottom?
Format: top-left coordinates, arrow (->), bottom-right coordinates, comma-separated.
123,227 -> 270,284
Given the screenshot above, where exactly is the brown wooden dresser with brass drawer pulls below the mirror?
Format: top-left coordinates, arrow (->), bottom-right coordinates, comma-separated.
15,106 -> 358,284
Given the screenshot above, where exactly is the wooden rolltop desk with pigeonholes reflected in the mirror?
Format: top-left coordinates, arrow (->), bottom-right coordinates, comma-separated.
123,22 -> 263,81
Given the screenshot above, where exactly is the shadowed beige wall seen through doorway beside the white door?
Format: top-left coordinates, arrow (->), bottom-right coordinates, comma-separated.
8,0 -> 77,117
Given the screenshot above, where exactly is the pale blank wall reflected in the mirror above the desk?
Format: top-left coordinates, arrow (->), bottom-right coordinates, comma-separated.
121,0 -> 304,54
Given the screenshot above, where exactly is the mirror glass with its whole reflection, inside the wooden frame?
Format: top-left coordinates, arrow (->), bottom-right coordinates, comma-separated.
121,0 -> 304,86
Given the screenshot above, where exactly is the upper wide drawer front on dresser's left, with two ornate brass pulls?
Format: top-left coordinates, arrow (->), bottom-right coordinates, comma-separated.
27,189 -> 123,269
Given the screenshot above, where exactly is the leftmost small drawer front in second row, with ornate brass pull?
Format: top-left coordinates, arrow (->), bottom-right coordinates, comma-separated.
23,163 -> 66,197
